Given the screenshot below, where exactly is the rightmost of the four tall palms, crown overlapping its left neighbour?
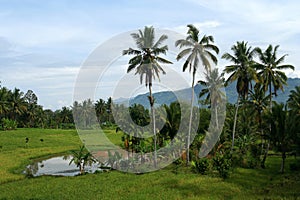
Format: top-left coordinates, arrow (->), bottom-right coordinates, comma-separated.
256,45 -> 294,167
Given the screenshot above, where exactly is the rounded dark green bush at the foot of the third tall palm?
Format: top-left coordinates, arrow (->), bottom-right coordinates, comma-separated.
213,154 -> 231,179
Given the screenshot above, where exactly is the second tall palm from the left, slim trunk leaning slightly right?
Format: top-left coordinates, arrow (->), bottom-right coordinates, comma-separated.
175,24 -> 219,165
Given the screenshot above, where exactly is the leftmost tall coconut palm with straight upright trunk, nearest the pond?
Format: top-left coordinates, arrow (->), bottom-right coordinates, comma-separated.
123,26 -> 172,167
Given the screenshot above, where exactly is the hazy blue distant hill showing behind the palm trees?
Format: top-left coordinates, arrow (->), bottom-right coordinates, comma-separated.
114,78 -> 300,108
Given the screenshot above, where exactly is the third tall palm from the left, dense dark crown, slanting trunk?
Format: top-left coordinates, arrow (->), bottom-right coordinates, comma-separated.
222,41 -> 258,150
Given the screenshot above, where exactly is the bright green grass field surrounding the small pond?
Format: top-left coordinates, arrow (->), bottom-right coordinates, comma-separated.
0,129 -> 300,199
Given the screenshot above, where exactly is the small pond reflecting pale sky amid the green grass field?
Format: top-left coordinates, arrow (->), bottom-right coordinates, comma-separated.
24,156 -> 101,176
